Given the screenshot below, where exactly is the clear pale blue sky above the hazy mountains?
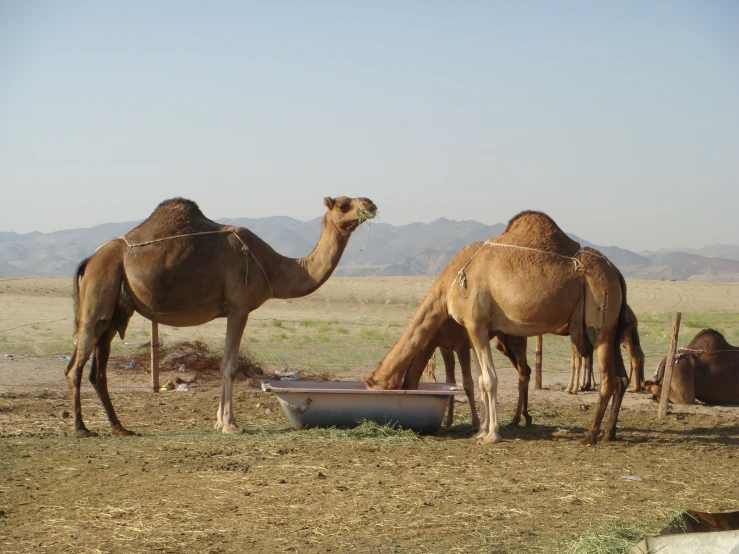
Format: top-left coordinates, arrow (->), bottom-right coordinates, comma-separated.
0,0 -> 739,250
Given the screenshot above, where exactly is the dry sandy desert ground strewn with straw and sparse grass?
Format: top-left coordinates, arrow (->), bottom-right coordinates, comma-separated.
0,277 -> 739,553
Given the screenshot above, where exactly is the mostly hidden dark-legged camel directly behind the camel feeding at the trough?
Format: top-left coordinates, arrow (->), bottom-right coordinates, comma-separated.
403,318 -> 532,431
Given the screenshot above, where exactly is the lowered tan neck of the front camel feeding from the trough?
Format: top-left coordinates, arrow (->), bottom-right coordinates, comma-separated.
370,282 -> 449,390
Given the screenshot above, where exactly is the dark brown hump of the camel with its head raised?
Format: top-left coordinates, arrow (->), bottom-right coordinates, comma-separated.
126,198 -> 224,243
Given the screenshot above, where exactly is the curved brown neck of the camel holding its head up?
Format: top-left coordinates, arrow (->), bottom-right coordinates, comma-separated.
268,212 -> 353,298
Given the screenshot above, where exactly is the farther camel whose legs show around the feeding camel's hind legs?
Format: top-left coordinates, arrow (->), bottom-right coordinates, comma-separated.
564,305 -> 644,394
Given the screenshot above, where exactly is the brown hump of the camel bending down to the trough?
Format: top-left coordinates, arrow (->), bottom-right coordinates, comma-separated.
490,210 -> 580,256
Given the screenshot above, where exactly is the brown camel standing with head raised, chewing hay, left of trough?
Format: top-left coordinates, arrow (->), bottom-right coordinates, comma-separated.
66,196 -> 377,437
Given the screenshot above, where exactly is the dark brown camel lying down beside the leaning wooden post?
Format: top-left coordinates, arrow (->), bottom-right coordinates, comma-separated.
644,329 -> 739,404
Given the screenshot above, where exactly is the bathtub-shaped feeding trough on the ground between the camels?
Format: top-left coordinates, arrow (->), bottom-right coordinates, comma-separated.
262,381 -> 464,433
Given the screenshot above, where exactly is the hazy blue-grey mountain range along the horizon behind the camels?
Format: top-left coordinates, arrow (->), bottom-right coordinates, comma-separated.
0,216 -> 739,282
